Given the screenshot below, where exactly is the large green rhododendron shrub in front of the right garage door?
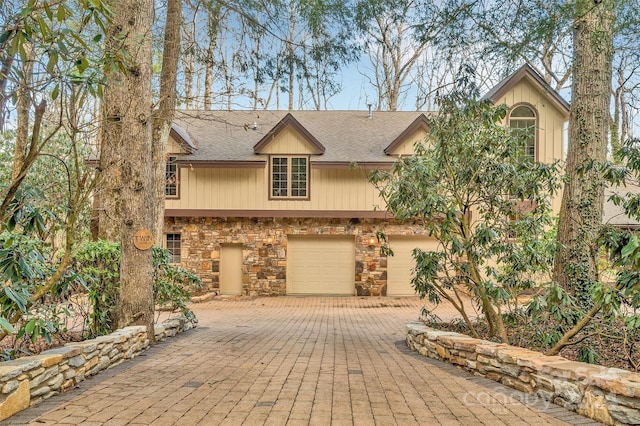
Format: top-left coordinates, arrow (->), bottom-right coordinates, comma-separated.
370,76 -> 558,340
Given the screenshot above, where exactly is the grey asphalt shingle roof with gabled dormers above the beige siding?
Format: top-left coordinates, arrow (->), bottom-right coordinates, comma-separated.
174,110 -> 425,163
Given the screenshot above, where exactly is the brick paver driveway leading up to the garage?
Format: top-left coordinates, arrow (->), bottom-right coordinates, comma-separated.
5,297 -> 590,426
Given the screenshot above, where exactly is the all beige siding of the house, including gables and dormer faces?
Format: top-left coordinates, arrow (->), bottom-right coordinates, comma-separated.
166,86 -> 565,212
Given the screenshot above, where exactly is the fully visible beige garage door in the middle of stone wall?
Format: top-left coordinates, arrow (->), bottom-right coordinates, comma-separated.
287,235 -> 355,295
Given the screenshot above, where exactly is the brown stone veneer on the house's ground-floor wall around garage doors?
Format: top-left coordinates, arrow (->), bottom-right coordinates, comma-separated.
165,217 -> 432,296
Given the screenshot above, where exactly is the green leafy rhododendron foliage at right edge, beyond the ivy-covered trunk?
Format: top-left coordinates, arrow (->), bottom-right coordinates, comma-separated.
510,141 -> 640,358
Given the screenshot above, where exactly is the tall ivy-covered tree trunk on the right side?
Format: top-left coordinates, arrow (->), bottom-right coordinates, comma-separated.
554,0 -> 615,307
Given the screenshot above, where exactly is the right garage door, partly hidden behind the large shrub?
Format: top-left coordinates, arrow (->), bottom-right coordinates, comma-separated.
387,236 -> 438,296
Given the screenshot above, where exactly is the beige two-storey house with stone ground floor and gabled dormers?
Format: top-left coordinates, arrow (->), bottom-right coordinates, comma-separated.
165,66 -> 569,296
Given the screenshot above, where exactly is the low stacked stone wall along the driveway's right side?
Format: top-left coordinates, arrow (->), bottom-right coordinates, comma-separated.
406,323 -> 640,425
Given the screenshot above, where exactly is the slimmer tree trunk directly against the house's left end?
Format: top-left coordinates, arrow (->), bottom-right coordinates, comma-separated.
151,0 -> 182,246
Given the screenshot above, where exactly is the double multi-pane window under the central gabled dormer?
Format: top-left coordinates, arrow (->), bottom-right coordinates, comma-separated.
270,156 -> 309,199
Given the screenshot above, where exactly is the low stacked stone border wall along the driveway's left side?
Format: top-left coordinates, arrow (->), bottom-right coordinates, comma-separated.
0,317 -> 197,421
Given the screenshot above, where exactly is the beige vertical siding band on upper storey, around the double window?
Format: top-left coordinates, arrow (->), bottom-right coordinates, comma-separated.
166,166 -> 383,211
